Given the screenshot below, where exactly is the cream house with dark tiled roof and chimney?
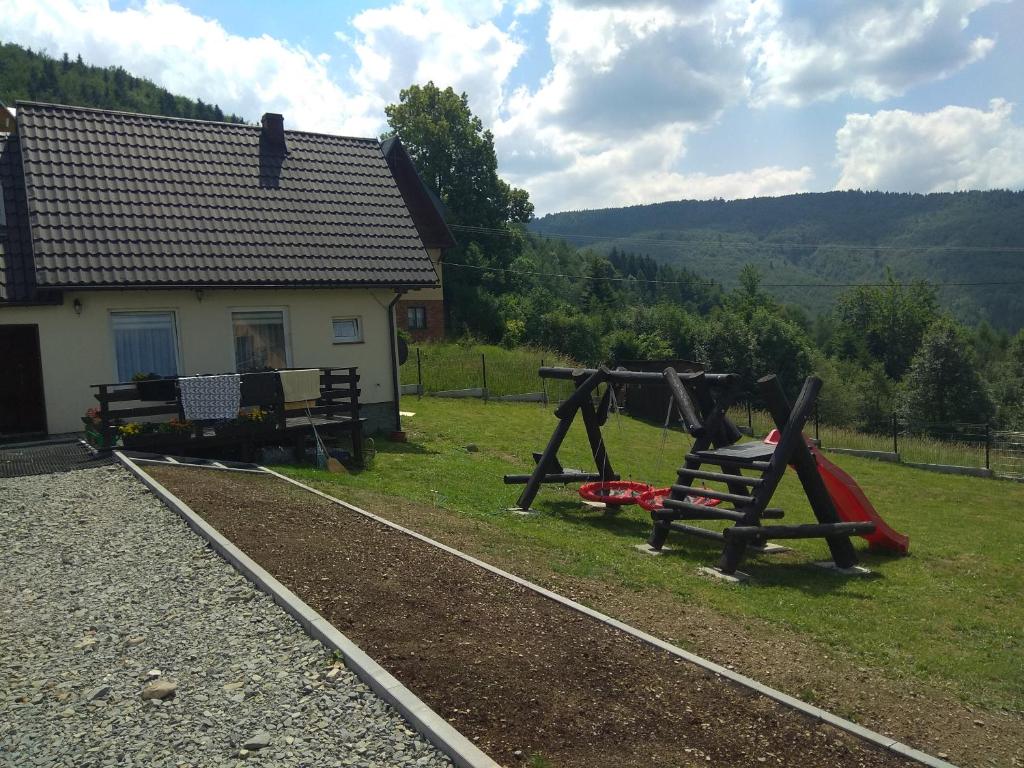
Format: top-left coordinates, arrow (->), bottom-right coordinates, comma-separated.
0,102 -> 451,438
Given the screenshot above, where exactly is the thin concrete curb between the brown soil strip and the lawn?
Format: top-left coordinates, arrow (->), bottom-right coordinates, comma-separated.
264,467 -> 956,768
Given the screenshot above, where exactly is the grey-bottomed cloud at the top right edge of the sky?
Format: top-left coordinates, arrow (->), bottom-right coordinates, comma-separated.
743,0 -> 995,106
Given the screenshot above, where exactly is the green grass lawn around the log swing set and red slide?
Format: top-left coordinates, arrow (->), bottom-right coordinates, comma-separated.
282,397 -> 1024,711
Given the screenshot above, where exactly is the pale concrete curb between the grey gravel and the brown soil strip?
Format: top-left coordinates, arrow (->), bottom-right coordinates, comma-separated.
114,451 -> 501,768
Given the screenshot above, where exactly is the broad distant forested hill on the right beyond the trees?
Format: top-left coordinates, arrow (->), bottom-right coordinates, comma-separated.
530,190 -> 1024,331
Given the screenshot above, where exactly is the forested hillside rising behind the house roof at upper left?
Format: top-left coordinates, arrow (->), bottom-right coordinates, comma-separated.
0,43 -> 244,123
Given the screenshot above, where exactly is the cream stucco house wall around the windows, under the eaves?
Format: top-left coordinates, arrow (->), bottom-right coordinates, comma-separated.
0,288 -> 394,433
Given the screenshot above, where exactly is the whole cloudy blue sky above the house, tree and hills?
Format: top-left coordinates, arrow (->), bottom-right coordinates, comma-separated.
0,0 -> 1024,213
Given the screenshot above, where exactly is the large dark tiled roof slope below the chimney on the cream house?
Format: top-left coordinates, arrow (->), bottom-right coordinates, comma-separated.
17,102 -> 437,287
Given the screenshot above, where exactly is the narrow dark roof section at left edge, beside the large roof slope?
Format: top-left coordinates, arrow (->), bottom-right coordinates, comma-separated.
0,133 -> 36,302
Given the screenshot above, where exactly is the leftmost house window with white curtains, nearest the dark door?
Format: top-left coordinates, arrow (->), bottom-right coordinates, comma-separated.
111,312 -> 178,382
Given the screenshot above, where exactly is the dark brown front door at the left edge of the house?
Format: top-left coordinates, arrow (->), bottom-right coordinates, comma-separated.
0,326 -> 46,437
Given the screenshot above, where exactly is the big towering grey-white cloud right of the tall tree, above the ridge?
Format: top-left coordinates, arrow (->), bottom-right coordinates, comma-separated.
495,0 -> 765,212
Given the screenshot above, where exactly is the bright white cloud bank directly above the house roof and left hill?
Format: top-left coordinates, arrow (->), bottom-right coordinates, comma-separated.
0,0 -> 374,134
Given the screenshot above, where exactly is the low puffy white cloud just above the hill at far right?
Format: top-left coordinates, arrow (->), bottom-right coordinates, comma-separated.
836,99 -> 1024,191
